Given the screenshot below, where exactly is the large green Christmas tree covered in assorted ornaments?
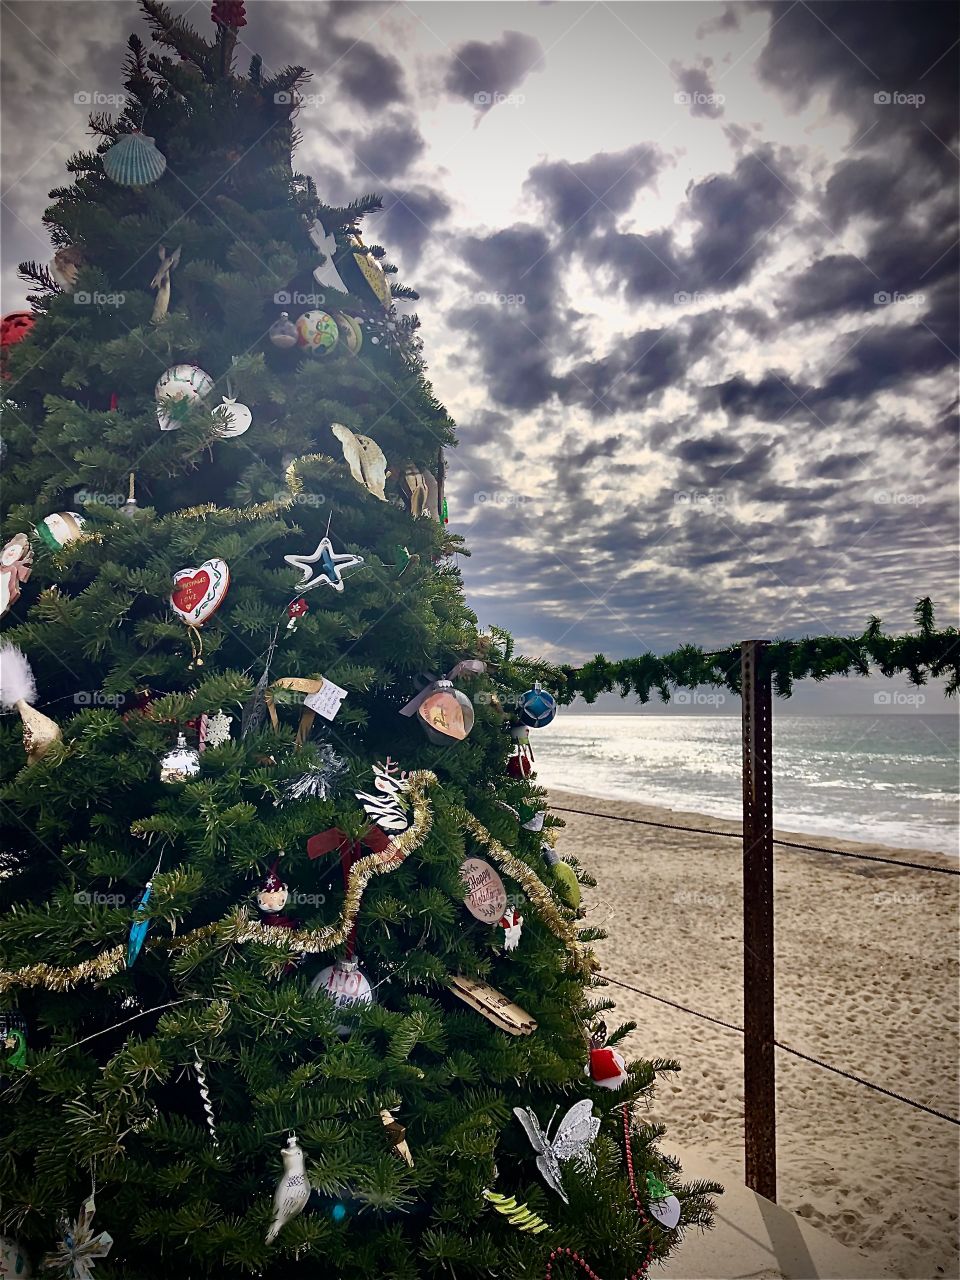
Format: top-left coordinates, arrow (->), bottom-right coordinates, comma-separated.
0,0 -> 717,1280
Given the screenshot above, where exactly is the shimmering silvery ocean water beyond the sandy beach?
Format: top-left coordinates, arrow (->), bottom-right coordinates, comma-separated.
530,712 -> 960,855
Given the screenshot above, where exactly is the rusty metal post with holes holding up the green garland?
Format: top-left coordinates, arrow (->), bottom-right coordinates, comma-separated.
740,640 -> 777,1201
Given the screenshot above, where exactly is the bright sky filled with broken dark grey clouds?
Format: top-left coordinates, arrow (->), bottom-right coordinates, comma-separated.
0,0 -> 957,709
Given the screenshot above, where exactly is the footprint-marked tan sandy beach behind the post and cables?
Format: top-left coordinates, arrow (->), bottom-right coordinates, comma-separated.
550,791 -> 960,1280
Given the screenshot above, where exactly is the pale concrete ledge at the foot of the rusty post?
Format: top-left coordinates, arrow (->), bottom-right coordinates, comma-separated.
650,1144 -> 893,1280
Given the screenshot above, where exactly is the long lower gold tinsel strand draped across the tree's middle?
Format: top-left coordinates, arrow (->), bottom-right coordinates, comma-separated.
0,769 -> 596,993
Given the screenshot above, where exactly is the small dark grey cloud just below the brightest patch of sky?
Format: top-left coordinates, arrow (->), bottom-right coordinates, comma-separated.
525,142 -> 664,233
